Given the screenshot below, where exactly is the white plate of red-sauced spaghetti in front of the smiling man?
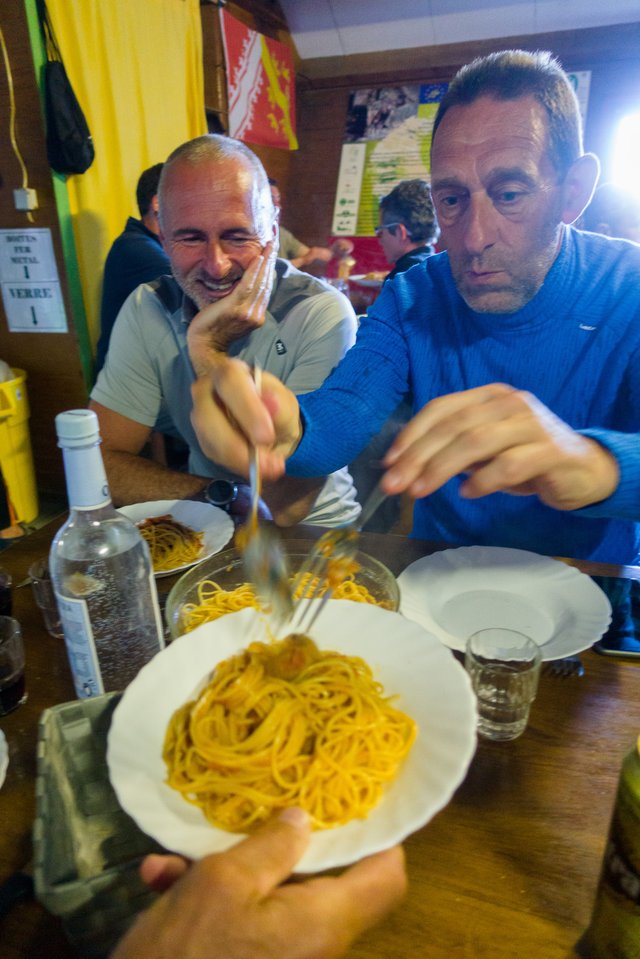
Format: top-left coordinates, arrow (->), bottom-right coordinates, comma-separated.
118,499 -> 233,576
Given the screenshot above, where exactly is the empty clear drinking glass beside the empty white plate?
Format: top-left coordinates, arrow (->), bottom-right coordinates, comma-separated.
465,627 -> 542,740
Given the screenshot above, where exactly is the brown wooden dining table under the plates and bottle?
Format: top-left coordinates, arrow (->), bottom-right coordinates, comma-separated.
0,522 -> 640,959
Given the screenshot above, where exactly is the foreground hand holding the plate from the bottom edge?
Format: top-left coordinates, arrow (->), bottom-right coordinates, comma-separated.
112,810 -> 406,959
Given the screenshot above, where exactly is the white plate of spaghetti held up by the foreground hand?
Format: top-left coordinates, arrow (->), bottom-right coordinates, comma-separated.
107,600 -> 476,872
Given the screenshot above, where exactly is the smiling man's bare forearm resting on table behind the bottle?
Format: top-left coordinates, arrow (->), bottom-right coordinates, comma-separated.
102,450 -> 209,506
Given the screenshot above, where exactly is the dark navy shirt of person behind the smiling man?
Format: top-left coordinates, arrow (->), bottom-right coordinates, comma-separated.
96,216 -> 171,375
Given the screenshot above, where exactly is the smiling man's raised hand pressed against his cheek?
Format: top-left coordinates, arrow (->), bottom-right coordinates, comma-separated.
187,243 -> 275,376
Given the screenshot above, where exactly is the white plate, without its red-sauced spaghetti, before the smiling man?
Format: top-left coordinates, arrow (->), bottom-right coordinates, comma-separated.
118,499 -> 233,577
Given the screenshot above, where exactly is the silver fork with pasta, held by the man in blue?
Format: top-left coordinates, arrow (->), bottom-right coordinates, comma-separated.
288,486 -> 387,633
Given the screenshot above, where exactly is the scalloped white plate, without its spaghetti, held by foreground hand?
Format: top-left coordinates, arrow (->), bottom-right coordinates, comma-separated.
107,600 -> 476,872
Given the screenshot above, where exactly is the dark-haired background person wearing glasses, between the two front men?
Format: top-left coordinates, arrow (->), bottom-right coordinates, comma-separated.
375,180 -> 440,280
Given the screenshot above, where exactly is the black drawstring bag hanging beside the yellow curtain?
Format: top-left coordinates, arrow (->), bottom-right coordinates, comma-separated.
42,7 -> 95,173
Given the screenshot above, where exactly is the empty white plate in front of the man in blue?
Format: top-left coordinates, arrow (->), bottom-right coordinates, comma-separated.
398,546 -> 611,661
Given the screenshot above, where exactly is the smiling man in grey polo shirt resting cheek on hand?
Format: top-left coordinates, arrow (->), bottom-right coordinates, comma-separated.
90,135 -> 360,526
